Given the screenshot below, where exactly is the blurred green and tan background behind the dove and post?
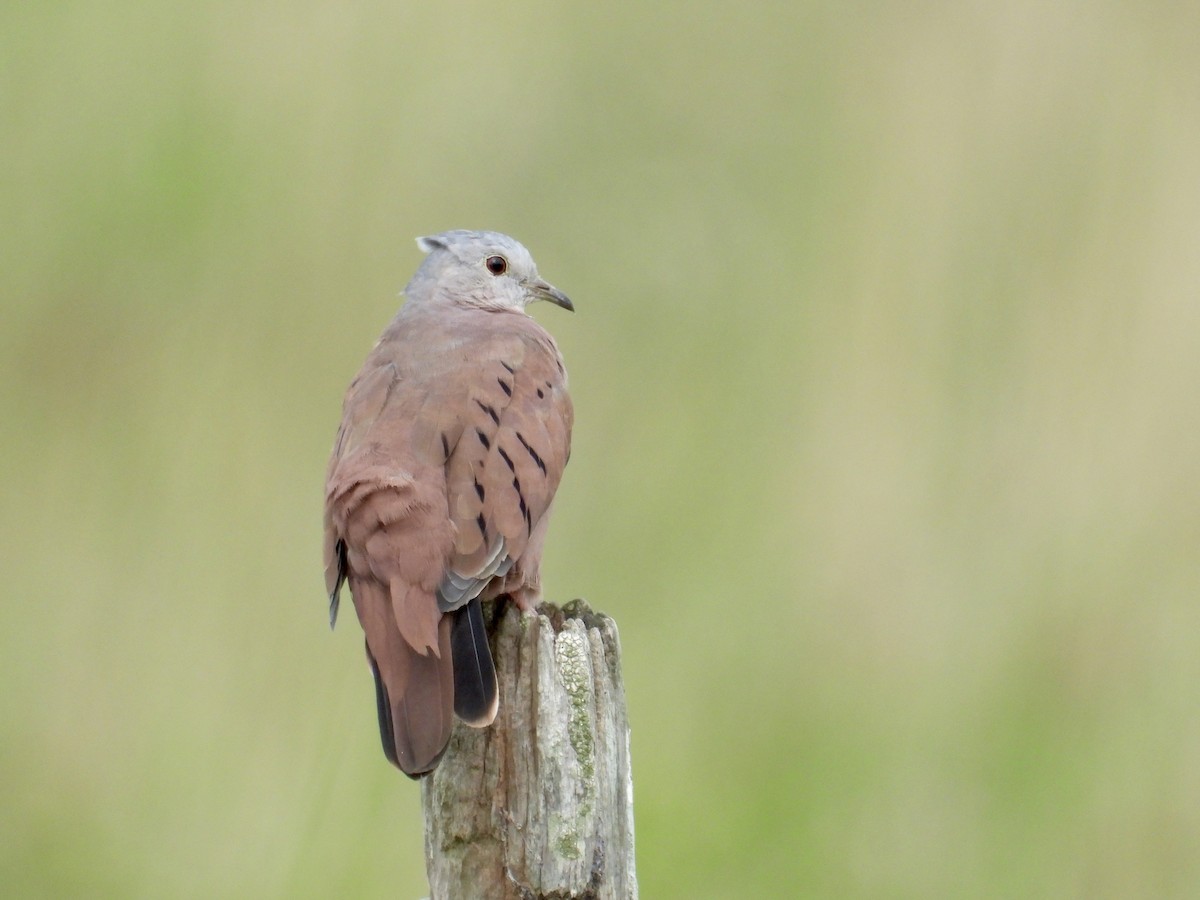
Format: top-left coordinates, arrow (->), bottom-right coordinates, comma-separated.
0,1 -> 1200,898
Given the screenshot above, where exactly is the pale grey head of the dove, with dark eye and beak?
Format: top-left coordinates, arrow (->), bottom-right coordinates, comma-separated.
404,232 -> 575,312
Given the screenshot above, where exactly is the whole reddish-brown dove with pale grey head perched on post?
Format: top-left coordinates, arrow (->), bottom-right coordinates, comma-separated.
324,230 -> 575,779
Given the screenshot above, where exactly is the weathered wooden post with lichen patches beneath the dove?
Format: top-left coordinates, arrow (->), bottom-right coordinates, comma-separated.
421,600 -> 637,900
